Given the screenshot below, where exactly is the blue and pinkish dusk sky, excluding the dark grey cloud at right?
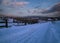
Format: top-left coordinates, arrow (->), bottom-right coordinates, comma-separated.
0,0 -> 60,16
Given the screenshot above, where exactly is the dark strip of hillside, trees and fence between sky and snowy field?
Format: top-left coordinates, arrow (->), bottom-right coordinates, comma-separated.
0,16 -> 60,28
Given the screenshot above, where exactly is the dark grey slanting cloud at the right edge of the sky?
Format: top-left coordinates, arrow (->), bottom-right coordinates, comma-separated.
42,3 -> 60,13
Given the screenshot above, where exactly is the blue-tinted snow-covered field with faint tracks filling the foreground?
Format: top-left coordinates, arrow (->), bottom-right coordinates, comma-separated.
0,21 -> 60,43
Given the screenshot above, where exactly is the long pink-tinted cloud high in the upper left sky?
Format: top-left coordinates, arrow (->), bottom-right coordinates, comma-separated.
3,0 -> 29,7
